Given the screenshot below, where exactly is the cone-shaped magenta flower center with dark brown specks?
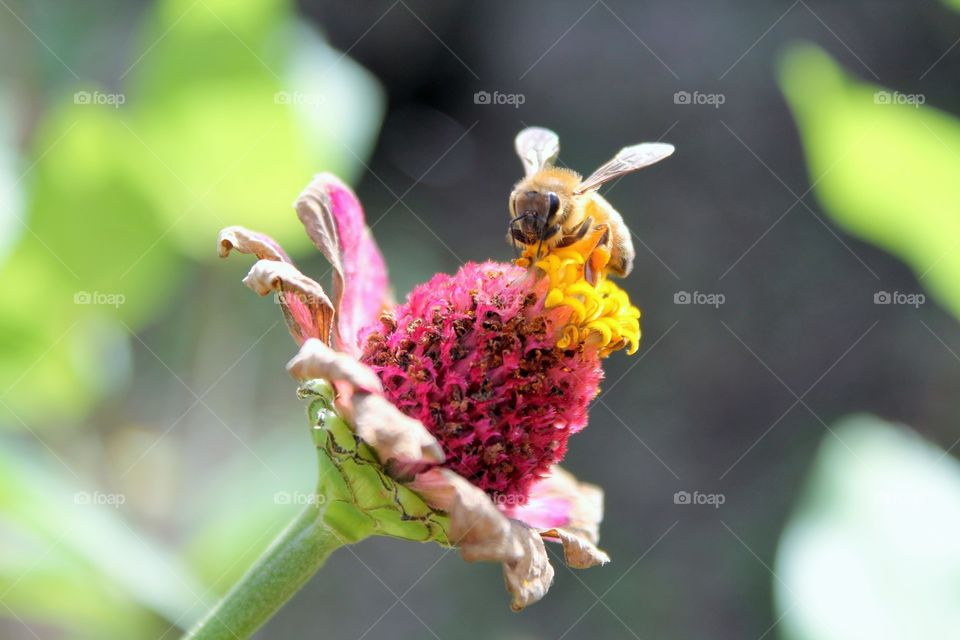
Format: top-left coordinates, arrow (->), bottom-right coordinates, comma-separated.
361,262 -> 602,506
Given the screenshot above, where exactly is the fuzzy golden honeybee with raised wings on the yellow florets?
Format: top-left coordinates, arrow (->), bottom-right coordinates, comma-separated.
507,127 -> 673,284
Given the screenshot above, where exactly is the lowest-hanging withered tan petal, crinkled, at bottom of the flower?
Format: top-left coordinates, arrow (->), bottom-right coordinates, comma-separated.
408,469 -> 553,611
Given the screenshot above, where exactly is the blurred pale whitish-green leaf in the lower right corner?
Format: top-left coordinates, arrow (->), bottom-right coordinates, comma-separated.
774,416 -> 960,640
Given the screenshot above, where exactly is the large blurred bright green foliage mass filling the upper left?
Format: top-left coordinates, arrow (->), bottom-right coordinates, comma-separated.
0,0 -> 383,429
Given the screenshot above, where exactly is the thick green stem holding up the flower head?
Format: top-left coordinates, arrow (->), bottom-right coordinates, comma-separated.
183,505 -> 345,640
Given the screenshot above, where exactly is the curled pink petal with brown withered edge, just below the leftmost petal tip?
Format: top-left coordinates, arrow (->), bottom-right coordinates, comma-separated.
243,259 -> 334,344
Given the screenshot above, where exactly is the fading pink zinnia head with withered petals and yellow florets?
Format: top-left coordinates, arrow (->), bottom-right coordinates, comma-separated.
219,174 -> 640,610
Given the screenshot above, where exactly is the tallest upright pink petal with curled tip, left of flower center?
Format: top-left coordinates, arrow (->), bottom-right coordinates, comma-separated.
295,173 -> 389,354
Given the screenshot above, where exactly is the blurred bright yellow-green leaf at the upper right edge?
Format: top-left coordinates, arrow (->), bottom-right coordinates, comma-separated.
780,45 -> 960,317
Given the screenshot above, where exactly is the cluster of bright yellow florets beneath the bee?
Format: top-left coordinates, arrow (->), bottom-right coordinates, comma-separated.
517,245 -> 640,357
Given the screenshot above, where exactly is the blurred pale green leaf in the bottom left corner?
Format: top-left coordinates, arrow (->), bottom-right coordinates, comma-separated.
0,450 -> 204,638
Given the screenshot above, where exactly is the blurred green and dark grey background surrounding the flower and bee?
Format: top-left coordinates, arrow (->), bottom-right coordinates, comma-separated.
0,0 -> 960,640
